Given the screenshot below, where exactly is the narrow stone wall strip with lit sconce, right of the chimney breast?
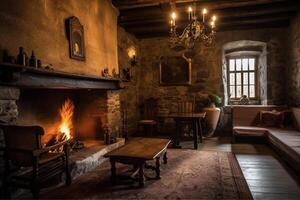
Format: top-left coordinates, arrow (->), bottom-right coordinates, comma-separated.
118,27 -> 143,134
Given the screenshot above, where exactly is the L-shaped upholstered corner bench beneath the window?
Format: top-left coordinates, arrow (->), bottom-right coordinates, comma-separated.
232,106 -> 300,172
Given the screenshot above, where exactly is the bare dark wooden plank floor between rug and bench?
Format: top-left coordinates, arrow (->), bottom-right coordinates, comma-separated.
192,137 -> 300,200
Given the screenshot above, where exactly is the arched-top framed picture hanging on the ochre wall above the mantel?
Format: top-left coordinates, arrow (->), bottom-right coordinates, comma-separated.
67,16 -> 85,61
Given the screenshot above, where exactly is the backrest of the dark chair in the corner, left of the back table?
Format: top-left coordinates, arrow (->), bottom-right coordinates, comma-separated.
141,98 -> 158,120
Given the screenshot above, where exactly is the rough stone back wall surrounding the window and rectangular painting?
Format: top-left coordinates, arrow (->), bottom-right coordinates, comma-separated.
139,28 -> 287,135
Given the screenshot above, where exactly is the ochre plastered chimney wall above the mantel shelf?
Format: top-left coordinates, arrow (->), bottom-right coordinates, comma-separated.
0,0 -> 118,76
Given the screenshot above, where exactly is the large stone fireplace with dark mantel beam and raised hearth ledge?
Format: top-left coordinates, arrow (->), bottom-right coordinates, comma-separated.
0,63 -> 124,181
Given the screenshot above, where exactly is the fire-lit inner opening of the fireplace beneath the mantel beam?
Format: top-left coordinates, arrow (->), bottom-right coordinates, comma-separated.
16,89 -> 119,143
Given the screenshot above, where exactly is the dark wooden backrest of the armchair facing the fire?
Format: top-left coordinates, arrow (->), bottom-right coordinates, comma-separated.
0,125 -> 44,166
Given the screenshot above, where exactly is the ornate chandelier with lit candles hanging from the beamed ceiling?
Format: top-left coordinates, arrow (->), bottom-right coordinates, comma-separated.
170,4 -> 217,50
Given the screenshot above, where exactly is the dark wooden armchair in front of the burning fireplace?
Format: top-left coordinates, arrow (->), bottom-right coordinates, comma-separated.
0,125 -> 71,198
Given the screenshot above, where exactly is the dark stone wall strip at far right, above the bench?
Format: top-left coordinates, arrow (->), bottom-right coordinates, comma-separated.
286,12 -> 300,107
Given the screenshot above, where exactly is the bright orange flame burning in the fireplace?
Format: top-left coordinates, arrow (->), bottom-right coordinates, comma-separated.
59,99 -> 74,140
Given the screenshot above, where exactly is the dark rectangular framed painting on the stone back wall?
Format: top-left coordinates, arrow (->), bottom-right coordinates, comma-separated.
159,56 -> 192,86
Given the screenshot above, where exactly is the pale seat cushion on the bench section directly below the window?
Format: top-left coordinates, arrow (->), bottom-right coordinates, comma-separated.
233,126 -> 268,136
